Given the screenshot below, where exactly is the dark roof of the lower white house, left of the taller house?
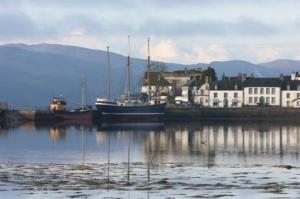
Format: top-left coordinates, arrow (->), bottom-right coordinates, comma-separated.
210,79 -> 243,90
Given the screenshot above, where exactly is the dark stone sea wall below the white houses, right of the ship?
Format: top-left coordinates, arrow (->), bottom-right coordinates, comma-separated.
166,107 -> 300,121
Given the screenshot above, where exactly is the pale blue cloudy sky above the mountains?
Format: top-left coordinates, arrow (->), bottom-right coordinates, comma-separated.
0,0 -> 300,64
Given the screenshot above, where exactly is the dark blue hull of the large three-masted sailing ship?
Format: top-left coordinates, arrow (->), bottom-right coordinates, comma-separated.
96,104 -> 166,123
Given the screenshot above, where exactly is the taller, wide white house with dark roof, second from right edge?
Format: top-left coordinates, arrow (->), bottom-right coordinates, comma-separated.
244,77 -> 284,106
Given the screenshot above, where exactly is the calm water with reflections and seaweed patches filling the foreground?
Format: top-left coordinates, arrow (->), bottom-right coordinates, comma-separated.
0,122 -> 300,198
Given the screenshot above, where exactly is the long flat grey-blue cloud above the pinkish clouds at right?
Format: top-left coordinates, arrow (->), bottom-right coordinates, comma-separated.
139,18 -> 279,36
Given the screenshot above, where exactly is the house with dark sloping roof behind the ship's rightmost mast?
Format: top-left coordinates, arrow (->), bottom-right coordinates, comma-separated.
142,72 -> 173,96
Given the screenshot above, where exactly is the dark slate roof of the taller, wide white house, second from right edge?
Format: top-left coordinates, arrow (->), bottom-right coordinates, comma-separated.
244,77 -> 284,87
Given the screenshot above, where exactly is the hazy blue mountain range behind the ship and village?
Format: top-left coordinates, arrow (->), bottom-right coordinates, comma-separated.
0,44 -> 300,108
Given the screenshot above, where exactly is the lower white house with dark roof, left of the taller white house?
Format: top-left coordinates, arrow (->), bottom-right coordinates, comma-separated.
209,79 -> 243,108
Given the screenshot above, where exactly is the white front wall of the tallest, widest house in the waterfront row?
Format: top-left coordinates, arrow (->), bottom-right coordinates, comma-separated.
244,87 -> 281,106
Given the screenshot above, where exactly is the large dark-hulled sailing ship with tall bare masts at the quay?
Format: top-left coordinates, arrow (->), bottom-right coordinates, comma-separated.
96,37 -> 166,123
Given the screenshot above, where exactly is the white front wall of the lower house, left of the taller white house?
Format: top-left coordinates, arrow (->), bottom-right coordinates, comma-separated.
209,90 -> 243,108
